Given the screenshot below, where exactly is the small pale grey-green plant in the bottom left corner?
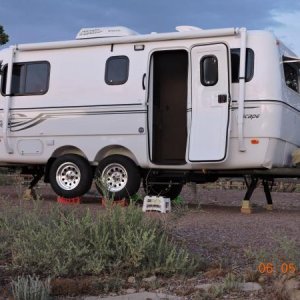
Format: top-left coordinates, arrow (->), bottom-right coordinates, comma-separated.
11,275 -> 50,300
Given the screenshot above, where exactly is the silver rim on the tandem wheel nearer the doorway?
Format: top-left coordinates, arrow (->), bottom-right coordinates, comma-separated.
101,163 -> 128,193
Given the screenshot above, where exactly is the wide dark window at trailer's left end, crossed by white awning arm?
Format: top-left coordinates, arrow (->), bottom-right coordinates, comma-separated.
1,62 -> 50,96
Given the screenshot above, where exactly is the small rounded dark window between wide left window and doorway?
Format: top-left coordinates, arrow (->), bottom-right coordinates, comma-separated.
105,56 -> 129,85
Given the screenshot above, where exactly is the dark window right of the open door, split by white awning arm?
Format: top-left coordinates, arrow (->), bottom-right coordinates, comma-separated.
230,48 -> 254,83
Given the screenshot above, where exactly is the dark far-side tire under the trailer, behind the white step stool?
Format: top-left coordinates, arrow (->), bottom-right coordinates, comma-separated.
143,180 -> 183,200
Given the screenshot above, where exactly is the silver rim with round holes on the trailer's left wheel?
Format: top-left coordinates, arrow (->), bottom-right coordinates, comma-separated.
56,162 -> 81,190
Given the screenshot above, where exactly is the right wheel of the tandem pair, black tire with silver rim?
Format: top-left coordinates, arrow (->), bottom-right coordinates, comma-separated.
95,155 -> 141,200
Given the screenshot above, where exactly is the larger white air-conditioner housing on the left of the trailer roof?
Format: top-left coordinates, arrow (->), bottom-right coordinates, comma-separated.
76,26 -> 137,40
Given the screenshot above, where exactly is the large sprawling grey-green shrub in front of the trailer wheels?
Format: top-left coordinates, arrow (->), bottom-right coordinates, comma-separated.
0,205 -> 198,276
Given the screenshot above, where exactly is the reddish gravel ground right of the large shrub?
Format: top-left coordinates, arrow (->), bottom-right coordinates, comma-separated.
178,186 -> 300,266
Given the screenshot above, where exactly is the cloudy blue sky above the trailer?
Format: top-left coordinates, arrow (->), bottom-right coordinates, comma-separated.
0,0 -> 300,55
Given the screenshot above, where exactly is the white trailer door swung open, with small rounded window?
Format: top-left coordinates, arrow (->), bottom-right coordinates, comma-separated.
187,43 -> 230,162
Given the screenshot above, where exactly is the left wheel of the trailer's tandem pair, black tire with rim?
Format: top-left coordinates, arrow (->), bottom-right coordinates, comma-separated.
49,154 -> 93,198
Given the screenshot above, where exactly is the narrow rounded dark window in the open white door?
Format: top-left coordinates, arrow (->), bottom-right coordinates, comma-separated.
200,55 -> 219,86
